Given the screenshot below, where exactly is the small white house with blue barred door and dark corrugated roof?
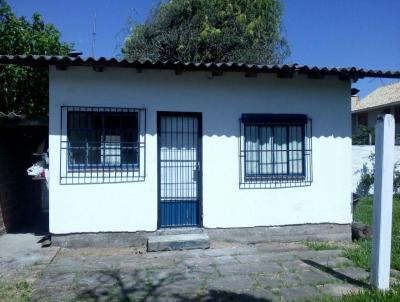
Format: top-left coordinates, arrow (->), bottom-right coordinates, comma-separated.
0,56 -> 399,245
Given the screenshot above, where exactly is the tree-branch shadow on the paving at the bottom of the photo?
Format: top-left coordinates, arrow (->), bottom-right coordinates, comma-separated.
76,270 -> 271,302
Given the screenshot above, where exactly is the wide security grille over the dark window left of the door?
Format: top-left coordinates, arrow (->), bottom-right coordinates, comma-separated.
60,106 -> 146,184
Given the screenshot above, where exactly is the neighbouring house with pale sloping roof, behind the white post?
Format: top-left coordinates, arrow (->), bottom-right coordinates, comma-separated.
351,82 -> 400,145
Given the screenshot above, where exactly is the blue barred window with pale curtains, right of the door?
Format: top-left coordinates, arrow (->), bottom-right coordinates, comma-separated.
239,114 -> 312,189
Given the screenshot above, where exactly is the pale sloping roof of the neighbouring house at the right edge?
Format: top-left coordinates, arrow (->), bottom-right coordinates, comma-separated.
351,82 -> 400,112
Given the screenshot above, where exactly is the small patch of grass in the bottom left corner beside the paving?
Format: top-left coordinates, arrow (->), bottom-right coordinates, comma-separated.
0,281 -> 32,302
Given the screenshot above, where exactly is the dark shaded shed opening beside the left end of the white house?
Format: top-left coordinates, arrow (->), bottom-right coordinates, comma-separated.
0,112 -> 49,234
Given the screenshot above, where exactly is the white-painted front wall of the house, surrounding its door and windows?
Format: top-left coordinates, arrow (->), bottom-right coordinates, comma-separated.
49,67 -> 351,234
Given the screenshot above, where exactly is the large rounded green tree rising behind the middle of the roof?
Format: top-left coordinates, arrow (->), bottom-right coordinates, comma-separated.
122,0 -> 289,64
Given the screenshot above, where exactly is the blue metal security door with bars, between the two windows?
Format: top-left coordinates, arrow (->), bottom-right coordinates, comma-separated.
157,112 -> 202,228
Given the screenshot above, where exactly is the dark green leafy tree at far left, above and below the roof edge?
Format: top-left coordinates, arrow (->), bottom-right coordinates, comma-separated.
0,0 -> 72,116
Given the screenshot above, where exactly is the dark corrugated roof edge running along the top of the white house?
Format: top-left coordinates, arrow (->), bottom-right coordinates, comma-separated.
0,55 -> 400,79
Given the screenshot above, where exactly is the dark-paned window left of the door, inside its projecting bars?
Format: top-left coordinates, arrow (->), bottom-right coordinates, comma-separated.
68,111 -> 139,169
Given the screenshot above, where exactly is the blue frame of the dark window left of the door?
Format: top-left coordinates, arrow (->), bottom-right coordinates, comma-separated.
66,110 -> 140,172
